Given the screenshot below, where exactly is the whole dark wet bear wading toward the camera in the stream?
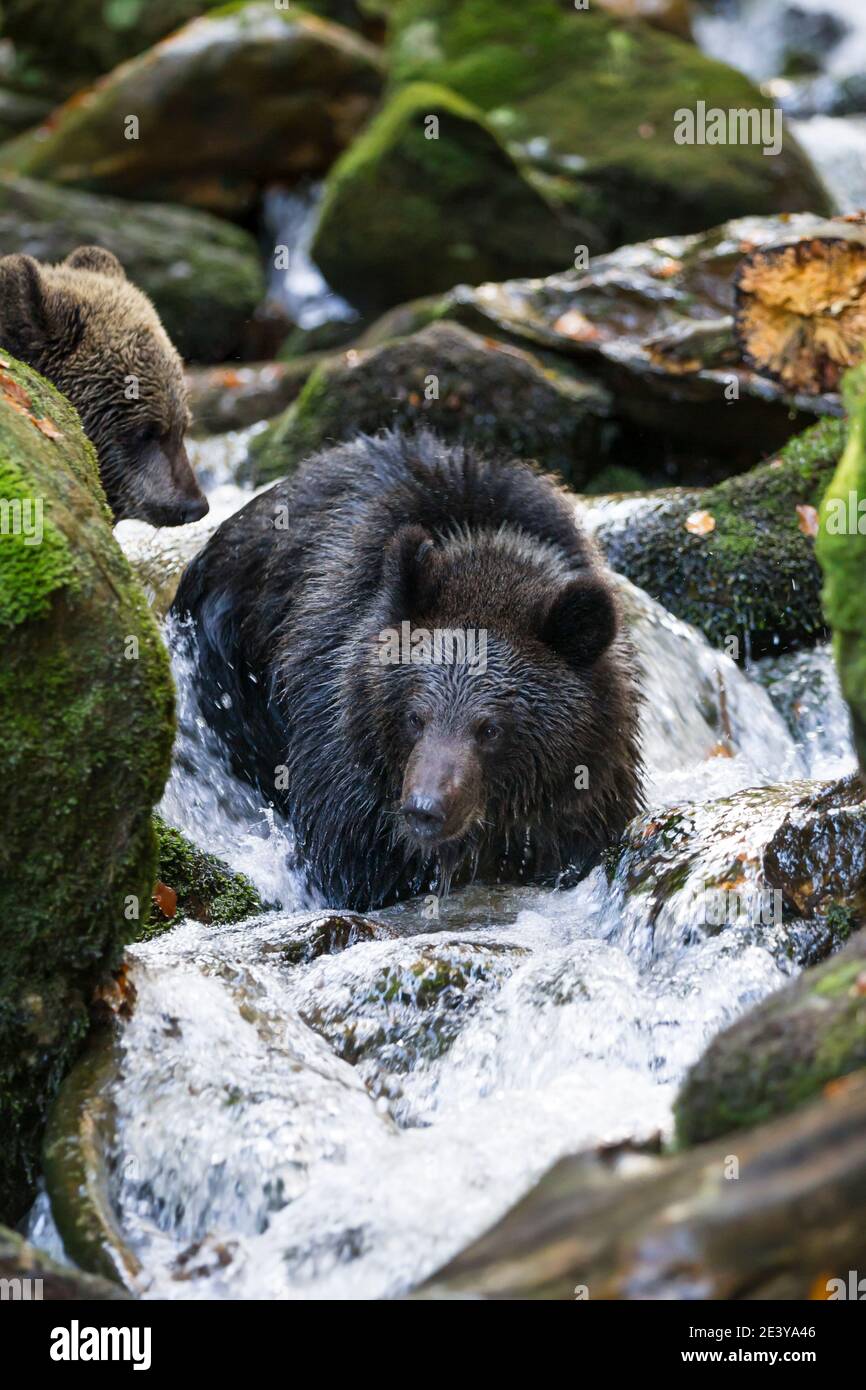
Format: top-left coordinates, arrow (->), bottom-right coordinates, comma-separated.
174,431 -> 641,909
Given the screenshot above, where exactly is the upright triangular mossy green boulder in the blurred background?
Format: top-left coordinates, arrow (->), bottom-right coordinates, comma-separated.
311,83 -> 577,313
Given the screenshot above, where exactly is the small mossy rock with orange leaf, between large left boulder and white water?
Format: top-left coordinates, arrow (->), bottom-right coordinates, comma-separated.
136,816 -> 264,941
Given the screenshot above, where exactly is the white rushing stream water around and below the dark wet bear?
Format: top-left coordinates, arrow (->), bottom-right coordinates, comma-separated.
88,443 -> 852,1298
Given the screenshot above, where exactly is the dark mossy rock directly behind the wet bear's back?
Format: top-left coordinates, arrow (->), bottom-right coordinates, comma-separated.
250,324 -> 609,482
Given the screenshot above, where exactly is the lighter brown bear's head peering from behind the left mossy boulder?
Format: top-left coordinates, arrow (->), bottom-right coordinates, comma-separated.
0,246 -> 207,525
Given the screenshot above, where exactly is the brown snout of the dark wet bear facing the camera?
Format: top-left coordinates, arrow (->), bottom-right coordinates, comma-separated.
400,735 -> 481,847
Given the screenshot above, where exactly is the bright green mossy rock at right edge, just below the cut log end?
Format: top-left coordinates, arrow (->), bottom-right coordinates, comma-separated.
817,367 -> 866,771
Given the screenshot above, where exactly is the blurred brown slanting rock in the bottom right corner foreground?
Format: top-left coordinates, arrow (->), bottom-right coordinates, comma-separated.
417,1072 -> 866,1302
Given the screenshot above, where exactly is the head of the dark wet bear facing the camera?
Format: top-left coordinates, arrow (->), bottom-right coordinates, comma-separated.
361,525 -> 639,872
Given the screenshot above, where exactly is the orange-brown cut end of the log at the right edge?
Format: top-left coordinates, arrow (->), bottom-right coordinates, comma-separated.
735,228 -> 866,395
